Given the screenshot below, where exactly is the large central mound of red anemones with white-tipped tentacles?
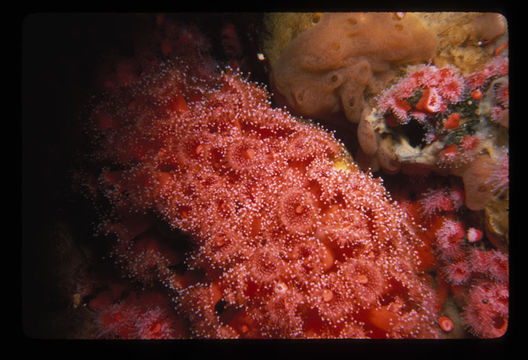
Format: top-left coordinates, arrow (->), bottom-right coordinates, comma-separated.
84,56 -> 444,338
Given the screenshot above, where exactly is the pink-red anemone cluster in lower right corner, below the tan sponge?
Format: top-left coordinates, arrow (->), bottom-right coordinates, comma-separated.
408,185 -> 509,338
